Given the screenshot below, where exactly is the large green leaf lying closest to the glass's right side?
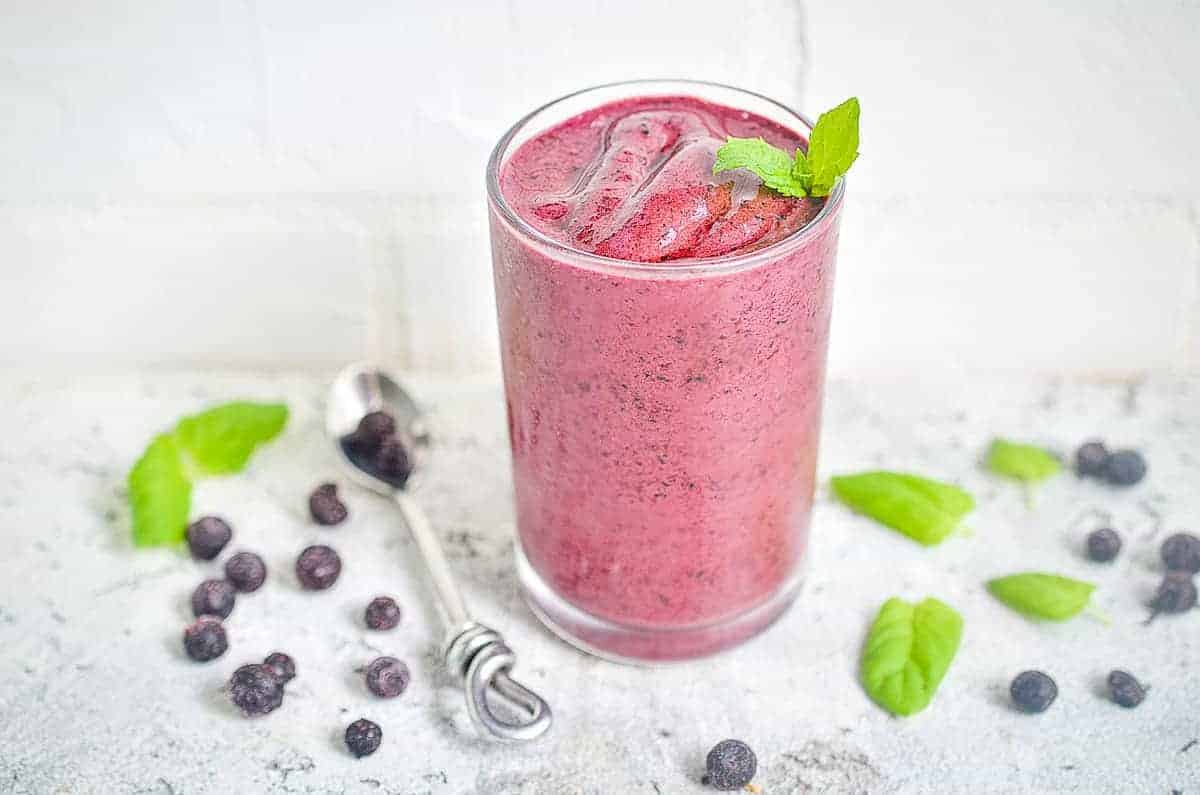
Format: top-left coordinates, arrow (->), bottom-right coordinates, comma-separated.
833,471 -> 974,546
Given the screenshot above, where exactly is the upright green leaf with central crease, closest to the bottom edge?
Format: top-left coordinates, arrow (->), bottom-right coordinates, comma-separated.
862,597 -> 962,716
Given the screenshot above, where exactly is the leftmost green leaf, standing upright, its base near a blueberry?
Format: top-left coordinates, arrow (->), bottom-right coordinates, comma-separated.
128,434 -> 192,546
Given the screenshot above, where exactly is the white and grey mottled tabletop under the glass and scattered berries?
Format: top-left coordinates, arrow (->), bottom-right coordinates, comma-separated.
0,372 -> 1200,795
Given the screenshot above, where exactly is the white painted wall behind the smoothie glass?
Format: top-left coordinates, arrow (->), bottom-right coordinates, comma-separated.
0,0 -> 1200,375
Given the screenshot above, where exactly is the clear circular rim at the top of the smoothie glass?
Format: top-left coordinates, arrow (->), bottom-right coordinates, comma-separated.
487,78 -> 846,275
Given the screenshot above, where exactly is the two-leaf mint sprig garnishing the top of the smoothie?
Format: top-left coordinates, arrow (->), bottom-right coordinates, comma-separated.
713,97 -> 859,198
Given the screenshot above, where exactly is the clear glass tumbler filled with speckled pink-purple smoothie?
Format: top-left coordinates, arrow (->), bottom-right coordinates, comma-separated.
491,84 -> 841,659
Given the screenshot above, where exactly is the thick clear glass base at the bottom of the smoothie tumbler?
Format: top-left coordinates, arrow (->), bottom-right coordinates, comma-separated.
515,542 -> 804,665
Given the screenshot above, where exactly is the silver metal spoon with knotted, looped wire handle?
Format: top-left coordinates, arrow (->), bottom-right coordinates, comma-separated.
325,364 -> 551,742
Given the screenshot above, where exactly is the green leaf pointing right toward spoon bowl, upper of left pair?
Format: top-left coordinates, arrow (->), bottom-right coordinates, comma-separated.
175,401 -> 288,474
